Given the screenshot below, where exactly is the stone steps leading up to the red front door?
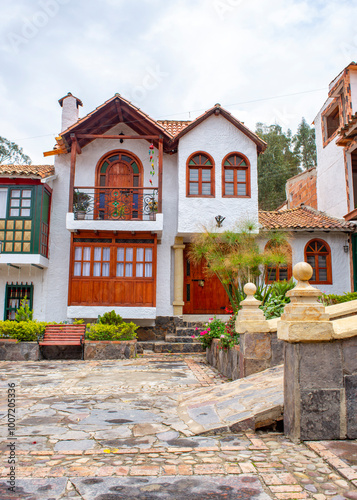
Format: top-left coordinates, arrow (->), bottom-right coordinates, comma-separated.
137,318 -> 205,354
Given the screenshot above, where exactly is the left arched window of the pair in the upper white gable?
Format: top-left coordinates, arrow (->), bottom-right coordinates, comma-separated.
186,152 -> 214,197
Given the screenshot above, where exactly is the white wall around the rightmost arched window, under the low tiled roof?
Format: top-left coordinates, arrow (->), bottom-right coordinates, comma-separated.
261,231 -> 351,294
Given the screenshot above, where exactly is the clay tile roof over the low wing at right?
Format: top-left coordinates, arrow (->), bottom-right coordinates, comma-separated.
259,206 -> 357,231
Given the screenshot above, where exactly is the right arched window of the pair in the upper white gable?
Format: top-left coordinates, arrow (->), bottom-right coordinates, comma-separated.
222,153 -> 250,198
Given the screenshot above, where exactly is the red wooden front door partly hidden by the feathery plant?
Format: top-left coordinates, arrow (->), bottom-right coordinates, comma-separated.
183,250 -> 230,314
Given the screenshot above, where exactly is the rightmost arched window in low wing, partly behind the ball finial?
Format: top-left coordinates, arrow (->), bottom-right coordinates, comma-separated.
305,240 -> 332,284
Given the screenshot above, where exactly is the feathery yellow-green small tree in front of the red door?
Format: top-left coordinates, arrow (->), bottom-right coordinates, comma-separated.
189,222 -> 291,311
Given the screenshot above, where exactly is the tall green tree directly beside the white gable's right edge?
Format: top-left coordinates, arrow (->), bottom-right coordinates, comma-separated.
256,123 -> 301,210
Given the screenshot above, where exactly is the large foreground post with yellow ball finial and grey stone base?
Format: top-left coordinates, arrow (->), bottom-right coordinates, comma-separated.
278,262 -> 336,441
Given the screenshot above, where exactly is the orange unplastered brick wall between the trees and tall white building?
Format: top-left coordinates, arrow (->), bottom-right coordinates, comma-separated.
286,168 -> 317,209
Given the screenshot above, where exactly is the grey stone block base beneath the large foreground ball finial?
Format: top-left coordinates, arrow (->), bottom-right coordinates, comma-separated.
284,337 -> 357,440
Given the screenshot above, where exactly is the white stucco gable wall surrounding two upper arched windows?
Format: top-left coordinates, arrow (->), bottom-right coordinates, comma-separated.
178,115 -> 258,236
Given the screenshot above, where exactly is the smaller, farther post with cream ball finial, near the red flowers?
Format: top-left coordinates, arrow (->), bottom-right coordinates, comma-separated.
236,283 -> 272,378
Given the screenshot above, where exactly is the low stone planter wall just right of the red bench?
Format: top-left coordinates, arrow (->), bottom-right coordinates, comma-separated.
84,340 -> 137,360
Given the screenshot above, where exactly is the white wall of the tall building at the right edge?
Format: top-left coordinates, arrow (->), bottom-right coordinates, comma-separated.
314,99 -> 349,218
